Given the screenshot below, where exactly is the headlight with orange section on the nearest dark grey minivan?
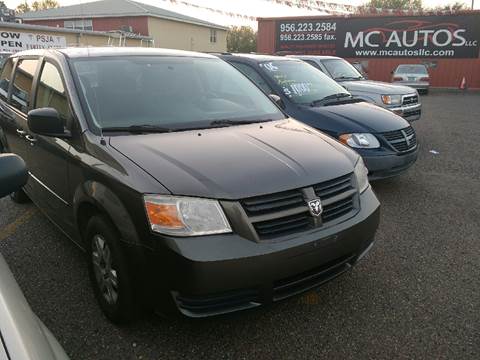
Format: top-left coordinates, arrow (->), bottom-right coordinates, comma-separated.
144,195 -> 232,236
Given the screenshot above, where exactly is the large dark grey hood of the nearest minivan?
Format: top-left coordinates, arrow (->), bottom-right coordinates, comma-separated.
110,119 -> 358,200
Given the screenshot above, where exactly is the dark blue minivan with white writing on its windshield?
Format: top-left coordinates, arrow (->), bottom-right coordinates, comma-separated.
220,54 -> 418,180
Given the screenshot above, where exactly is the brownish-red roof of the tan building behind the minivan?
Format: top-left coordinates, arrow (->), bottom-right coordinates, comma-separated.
19,0 -> 227,30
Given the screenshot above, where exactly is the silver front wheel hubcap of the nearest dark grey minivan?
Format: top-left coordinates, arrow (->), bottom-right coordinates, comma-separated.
92,235 -> 118,305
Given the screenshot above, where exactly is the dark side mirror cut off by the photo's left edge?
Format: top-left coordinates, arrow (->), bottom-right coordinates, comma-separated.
0,154 -> 28,198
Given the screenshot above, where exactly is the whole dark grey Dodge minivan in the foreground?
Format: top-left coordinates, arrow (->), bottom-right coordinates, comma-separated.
0,48 -> 379,322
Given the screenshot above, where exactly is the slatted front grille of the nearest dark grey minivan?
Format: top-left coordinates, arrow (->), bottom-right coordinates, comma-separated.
241,174 -> 358,240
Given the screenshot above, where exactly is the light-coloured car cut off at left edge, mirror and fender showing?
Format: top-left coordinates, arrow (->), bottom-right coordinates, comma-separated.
0,154 -> 68,360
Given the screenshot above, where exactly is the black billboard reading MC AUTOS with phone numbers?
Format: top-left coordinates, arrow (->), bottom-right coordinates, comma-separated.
276,14 -> 480,58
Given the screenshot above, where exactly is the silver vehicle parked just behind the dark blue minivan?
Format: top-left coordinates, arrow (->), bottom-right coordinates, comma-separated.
291,55 -> 422,121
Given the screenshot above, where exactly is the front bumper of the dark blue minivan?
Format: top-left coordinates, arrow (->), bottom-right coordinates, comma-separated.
359,145 -> 418,180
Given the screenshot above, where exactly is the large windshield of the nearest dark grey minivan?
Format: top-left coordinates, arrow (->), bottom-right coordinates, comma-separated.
72,56 -> 285,130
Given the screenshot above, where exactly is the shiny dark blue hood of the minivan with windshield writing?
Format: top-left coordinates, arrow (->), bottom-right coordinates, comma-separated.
298,102 -> 409,134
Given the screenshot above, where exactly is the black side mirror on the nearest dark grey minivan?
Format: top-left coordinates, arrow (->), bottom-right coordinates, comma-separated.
28,108 -> 71,138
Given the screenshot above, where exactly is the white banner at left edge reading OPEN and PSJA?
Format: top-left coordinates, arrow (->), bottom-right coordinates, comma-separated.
0,31 -> 67,52
